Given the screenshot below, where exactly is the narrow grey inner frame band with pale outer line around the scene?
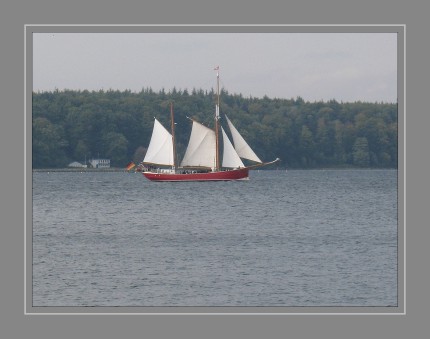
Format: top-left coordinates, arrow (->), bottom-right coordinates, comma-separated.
24,25 -> 406,315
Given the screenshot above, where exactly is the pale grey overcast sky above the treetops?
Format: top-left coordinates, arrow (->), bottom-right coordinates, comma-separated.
33,33 -> 397,102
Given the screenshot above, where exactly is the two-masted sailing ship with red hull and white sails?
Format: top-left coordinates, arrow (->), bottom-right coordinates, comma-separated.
142,67 -> 279,181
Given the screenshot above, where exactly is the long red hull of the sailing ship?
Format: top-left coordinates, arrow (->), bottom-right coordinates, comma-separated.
142,168 -> 249,181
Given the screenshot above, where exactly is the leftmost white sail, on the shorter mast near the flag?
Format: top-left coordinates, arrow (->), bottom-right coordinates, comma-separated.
143,119 -> 173,166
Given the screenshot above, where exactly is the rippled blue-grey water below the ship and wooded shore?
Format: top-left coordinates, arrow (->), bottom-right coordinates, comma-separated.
32,170 -> 397,306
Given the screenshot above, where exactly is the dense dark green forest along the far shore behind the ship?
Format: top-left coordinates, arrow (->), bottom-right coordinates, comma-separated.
32,88 -> 397,168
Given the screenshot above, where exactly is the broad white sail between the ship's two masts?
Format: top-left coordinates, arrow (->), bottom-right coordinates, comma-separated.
181,121 -> 216,168
